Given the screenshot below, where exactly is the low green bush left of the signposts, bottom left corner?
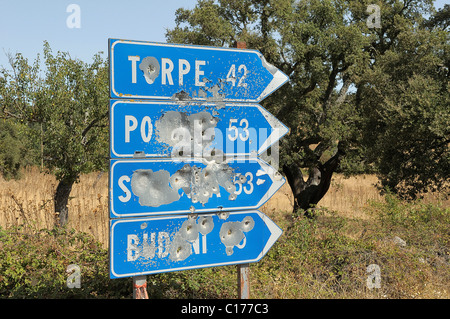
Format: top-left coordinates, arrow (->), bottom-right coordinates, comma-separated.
0,226 -> 131,299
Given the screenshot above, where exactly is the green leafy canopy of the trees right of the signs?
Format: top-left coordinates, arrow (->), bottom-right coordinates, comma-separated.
166,0 -> 450,198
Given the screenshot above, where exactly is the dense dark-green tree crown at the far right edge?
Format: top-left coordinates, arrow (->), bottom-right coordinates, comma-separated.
357,1 -> 450,199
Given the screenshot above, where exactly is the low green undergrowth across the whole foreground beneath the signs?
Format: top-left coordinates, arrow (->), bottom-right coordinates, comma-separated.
0,195 -> 450,299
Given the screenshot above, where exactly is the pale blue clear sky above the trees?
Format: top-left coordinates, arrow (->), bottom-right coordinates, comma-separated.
0,0 -> 448,68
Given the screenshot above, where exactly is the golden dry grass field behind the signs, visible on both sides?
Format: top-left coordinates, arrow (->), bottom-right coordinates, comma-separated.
0,167 -> 450,247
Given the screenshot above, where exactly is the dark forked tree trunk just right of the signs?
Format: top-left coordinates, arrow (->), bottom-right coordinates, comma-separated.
283,147 -> 344,216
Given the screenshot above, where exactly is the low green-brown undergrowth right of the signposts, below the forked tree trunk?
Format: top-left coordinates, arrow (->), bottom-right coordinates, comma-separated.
251,201 -> 450,299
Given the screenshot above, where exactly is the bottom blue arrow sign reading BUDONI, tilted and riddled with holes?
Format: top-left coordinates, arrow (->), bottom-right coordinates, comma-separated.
110,211 -> 282,278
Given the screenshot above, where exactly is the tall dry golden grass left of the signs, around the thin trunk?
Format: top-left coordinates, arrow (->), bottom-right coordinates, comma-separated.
0,167 -> 109,247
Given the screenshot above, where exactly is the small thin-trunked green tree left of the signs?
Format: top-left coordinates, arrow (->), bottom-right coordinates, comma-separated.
0,42 -> 109,226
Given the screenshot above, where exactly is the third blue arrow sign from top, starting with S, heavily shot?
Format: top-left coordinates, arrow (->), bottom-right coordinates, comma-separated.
110,157 -> 285,218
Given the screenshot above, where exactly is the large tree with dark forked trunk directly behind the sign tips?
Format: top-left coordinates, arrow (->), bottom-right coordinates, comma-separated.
166,0 -> 370,215
